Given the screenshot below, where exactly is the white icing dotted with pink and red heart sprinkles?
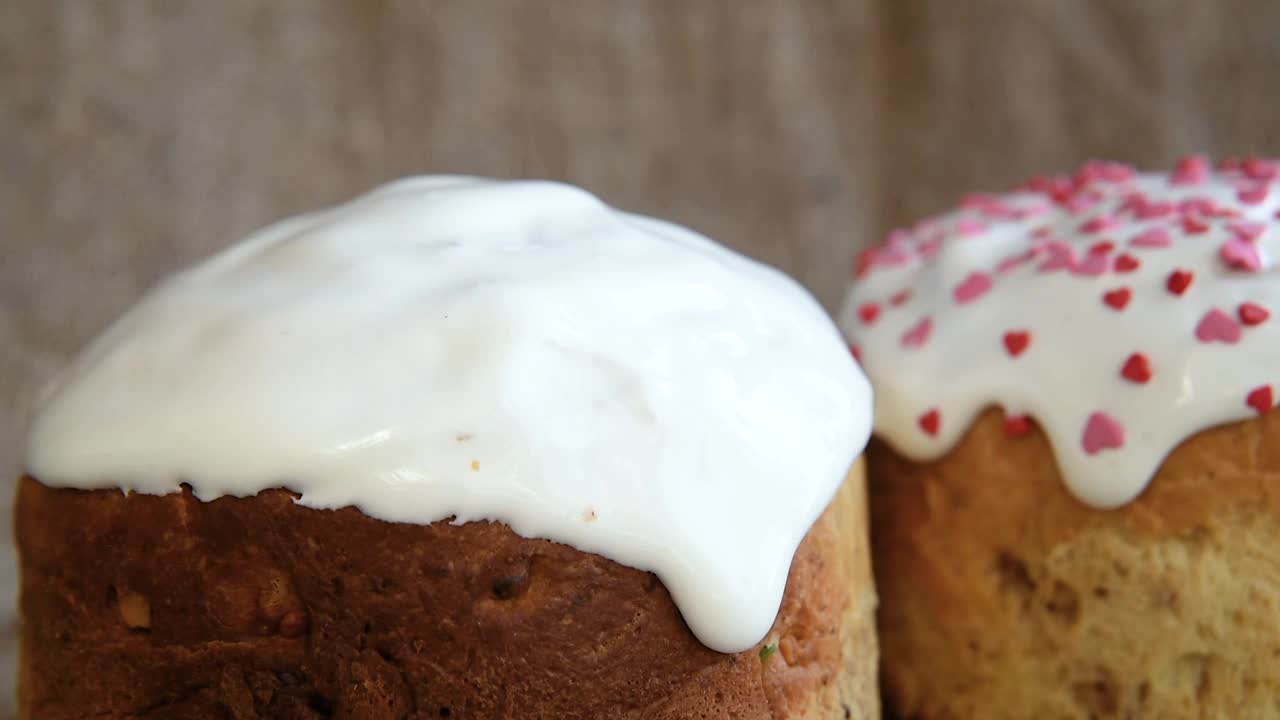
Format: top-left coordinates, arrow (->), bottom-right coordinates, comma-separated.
841,156 -> 1280,507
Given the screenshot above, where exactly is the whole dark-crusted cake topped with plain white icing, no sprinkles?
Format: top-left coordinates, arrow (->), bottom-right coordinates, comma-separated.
15,177 -> 879,720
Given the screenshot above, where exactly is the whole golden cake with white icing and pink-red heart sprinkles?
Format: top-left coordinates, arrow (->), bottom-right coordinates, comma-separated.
840,156 -> 1280,720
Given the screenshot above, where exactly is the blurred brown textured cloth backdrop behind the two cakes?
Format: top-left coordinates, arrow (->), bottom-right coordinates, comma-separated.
0,0 -> 1280,719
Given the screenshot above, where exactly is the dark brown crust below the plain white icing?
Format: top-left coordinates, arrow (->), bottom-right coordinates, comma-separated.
17,468 -> 878,720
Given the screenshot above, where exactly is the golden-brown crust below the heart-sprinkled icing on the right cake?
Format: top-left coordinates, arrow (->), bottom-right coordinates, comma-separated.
868,411 -> 1280,720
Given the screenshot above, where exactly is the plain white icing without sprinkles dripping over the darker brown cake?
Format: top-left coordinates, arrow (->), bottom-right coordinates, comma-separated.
27,177 -> 872,651
